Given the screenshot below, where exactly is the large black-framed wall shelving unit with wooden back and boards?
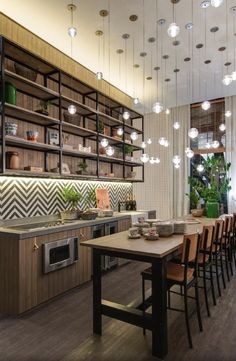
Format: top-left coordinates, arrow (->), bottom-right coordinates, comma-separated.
0,37 -> 144,182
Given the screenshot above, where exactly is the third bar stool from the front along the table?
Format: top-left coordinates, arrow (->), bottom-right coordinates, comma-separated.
212,219 -> 226,296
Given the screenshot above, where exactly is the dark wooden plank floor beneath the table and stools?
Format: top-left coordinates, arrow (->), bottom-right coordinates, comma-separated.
0,263 -> 236,361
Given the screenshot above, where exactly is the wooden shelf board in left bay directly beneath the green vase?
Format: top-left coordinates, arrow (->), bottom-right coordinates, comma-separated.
5,103 -> 60,126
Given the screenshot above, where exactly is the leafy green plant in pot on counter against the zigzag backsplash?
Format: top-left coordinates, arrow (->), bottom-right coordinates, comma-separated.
61,187 -> 82,219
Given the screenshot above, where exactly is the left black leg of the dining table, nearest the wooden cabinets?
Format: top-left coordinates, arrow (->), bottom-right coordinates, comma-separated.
93,249 -> 102,335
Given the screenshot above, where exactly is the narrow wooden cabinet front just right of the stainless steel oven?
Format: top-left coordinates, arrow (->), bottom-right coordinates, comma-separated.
78,227 -> 92,284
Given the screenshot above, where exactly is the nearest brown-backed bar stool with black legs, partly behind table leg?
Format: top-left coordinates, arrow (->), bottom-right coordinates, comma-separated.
141,233 -> 203,348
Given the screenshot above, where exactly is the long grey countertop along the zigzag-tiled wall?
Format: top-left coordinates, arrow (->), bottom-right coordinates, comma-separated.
0,211 -> 146,239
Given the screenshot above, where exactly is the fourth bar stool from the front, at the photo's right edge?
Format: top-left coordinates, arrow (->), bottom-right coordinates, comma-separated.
222,215 -> 233,281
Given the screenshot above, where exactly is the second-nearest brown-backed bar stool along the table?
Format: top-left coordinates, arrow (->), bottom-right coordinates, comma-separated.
198,226 -> 216,317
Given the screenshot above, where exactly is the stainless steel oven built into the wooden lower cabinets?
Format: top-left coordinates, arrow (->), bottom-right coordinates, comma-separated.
43,237 -> 79,273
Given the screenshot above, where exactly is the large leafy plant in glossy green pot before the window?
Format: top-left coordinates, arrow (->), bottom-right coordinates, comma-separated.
189,157 -> 231,218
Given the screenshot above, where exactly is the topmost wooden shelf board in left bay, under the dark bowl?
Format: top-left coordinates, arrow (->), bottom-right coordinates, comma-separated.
5,70 -> 59,100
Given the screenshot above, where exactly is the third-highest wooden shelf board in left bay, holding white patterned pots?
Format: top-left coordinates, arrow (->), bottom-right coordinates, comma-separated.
5,135 -> 60,152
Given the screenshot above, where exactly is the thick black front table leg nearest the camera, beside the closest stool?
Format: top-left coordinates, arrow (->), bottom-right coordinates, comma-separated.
152,259 -> 168,358
